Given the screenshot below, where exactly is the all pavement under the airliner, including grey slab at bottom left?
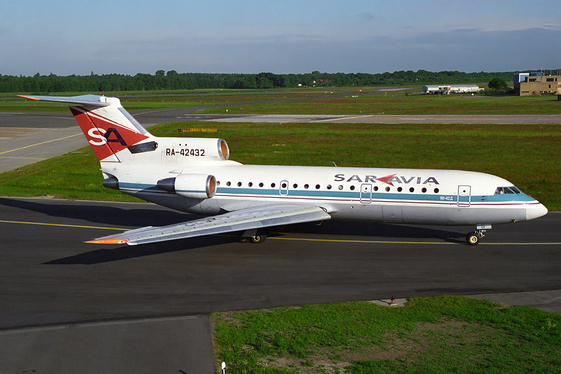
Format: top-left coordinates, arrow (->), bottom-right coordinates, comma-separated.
0,198 -> 561,373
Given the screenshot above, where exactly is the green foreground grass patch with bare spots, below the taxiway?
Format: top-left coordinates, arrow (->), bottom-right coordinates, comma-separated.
212,296 -> 561,374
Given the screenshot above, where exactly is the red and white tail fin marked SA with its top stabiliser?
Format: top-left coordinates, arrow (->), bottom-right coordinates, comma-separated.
20,95 -> 152,162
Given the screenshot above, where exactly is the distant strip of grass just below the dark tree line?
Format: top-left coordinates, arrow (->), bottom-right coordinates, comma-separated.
0,87 -> 561,114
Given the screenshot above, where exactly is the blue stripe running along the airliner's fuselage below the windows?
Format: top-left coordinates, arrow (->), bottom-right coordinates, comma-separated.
119,183 -> 535,204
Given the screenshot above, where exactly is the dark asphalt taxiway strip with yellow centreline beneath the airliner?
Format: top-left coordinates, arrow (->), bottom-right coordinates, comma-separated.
4,198 -> 561,329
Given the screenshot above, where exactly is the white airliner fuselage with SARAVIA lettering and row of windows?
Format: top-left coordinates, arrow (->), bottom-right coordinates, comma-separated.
111,162 -> 545,225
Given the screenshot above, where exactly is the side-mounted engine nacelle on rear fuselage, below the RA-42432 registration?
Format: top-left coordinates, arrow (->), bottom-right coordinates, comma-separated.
157,174 -> 216,199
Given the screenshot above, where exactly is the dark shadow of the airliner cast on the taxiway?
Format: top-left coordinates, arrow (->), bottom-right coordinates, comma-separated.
0,198 -> 465,265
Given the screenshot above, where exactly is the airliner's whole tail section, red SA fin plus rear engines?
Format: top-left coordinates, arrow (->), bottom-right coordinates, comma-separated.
20,95 -> 233,203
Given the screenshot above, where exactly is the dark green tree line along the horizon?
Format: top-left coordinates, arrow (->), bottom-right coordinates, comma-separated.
0,70 -> 514,93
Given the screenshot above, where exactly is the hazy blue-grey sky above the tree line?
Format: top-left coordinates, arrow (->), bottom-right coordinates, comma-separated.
0,0 -> 561,76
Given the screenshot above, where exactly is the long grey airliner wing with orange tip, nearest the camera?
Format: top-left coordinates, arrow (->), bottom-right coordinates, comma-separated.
86,205 -> 331,245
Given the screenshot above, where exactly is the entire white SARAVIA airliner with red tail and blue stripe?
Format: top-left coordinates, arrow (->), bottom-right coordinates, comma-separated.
22,95 -> 547,245
